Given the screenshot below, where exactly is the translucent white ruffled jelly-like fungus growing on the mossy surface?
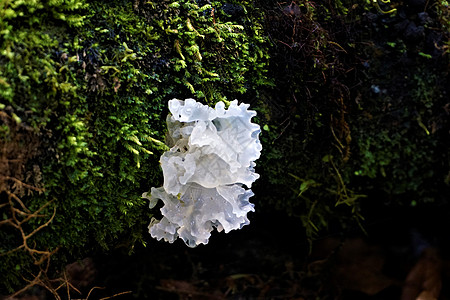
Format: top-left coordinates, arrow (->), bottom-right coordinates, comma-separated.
142,99 -> 262,247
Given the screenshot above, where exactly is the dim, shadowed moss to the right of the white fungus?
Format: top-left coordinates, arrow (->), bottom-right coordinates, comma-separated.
256,1 -> 449,237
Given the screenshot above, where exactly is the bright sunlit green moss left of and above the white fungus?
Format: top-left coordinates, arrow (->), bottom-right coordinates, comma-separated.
0,0 -> 274,293
